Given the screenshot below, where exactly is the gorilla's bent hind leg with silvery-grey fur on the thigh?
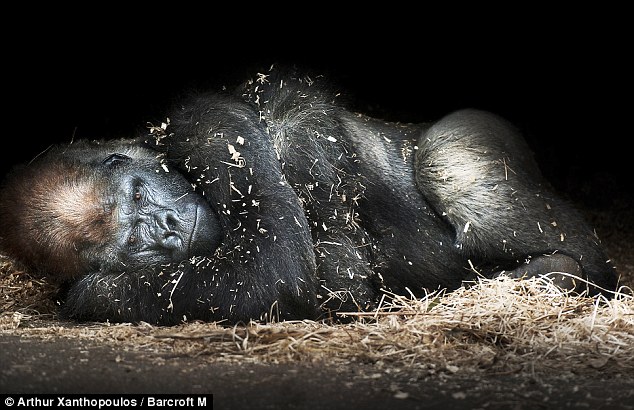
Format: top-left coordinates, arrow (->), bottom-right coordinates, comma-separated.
415,110 -> 616,291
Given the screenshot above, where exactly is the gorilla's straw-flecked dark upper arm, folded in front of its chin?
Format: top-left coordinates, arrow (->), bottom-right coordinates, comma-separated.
157,94 -> 316,320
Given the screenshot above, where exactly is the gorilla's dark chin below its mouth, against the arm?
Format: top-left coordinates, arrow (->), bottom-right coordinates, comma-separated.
187,203 -> 221,258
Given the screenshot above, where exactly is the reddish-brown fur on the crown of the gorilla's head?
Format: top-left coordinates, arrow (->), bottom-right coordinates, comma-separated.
0,162 -> 116,279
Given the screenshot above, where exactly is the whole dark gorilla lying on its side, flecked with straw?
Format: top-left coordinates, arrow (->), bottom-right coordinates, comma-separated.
0,69 -> 617,324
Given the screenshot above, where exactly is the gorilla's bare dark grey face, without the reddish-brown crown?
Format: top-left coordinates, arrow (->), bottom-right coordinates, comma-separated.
94,152 -> 220,270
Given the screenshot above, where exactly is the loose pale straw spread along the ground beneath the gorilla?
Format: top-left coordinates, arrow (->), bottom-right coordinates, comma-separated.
0,255 -> 634,373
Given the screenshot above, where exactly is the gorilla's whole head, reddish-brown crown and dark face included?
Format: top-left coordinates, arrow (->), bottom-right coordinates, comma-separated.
0,141 -> 221,278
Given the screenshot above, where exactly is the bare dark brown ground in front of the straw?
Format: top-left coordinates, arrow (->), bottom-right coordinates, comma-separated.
0,336 -> 634,409
